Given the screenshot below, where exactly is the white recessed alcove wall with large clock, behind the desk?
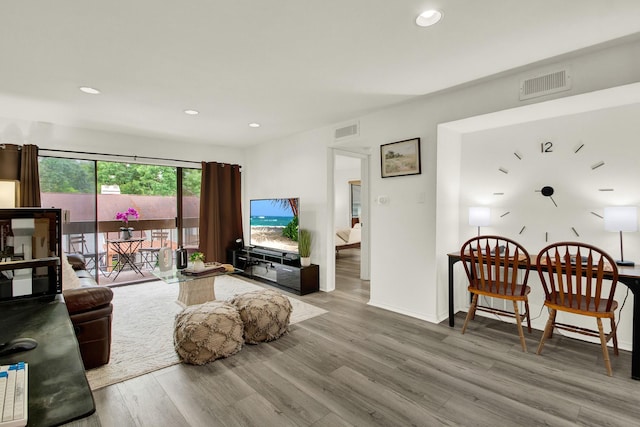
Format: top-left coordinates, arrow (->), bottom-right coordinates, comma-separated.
439,101 -> 640,349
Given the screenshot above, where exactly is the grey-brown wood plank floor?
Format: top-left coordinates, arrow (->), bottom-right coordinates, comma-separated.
71,250 -> 640,427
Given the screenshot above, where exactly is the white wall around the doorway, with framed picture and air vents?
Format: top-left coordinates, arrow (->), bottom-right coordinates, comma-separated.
246,35 -> 640,336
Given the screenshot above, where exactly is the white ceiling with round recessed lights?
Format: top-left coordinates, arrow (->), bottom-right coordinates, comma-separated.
0,0 -> 640,147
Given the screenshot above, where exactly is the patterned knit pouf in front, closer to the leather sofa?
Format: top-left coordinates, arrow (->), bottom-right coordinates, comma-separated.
173,301 -> 243,365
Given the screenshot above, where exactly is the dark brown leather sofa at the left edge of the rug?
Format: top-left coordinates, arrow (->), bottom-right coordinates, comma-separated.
62,254 -> 113,369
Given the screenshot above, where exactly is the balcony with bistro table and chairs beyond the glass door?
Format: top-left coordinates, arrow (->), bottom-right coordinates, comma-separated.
42,193 -> 200,285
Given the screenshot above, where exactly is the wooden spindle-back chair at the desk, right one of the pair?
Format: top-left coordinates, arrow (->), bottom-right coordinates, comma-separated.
536,242 -> 618,376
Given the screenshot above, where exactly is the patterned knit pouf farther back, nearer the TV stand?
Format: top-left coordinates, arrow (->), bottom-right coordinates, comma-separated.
231,289 -> 293,344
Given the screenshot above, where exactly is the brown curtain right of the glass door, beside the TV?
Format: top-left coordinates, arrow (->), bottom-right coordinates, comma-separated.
199,162 -> 244,262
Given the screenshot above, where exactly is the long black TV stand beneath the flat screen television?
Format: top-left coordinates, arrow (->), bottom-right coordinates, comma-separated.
231,247 -> 320,295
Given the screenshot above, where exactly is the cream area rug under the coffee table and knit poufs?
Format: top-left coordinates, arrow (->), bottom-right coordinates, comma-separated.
87,276 -> 326,390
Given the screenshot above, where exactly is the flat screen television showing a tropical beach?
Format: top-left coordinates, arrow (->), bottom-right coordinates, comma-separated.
250,197 -> 300,254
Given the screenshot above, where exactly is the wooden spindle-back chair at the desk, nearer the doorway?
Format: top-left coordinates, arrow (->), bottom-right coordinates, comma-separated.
460,236 -> 531,352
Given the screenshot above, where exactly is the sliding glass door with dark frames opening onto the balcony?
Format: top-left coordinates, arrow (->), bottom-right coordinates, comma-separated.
40,157 -> 201,284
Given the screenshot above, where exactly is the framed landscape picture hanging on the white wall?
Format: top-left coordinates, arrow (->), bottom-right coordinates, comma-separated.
380,138 -> 422,178
